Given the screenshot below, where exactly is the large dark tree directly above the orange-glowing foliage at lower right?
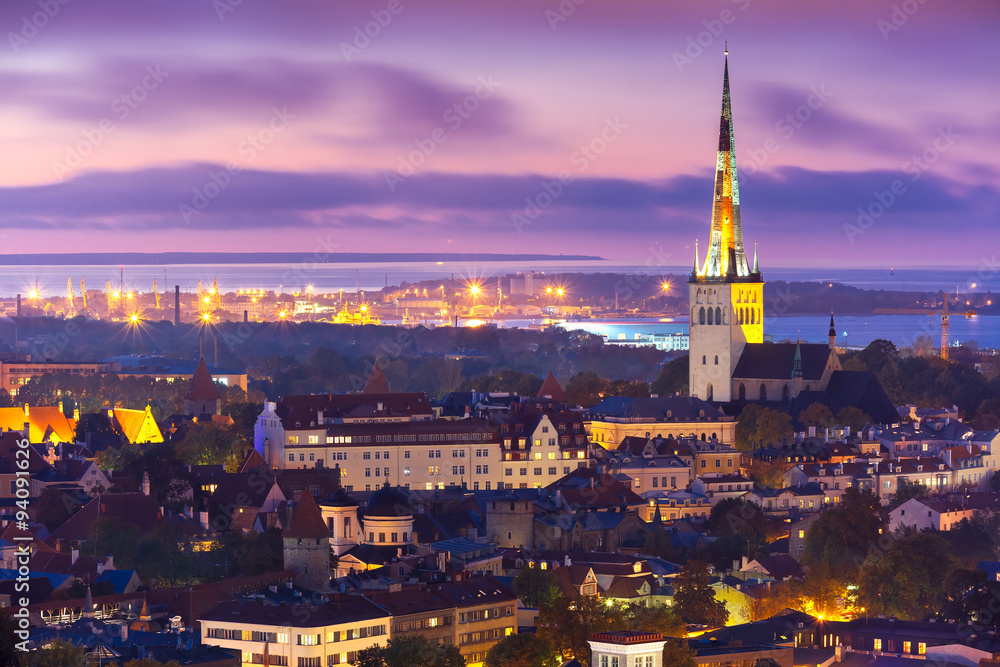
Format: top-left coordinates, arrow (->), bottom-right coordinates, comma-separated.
802,486 -> 889,583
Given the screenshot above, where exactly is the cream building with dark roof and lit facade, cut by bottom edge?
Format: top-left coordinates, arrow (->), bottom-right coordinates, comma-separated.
198,595 -> 392,667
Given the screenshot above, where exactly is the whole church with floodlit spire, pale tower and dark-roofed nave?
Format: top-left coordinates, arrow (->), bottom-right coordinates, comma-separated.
688,50 -> 898,428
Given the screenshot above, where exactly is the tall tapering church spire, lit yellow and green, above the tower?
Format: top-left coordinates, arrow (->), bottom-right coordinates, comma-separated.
698,45 -> 750,279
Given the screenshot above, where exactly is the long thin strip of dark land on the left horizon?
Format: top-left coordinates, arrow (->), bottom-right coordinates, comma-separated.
0,252 -> 604,266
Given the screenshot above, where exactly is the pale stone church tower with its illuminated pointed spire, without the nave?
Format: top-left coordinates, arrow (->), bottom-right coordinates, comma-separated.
688,49 -> 764,403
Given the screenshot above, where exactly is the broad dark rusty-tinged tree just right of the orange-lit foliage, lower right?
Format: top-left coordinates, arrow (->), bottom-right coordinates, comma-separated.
858,532 -> 955,620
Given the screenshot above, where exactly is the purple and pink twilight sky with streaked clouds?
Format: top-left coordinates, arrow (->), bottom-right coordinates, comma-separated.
0,0 -> 1000,273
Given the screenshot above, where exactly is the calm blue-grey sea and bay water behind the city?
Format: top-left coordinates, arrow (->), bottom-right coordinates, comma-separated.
0,260 -> 1000,349
